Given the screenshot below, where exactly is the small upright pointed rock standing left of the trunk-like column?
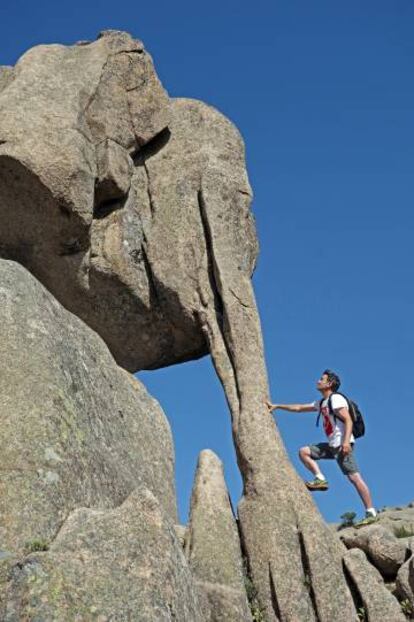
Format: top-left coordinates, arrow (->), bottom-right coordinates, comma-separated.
185,450 -> 252,622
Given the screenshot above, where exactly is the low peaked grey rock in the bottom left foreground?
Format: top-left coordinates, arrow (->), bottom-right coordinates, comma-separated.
1,488 -> 201,622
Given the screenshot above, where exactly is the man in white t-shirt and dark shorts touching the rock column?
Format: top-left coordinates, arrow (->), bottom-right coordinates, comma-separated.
266,369 -> 377,525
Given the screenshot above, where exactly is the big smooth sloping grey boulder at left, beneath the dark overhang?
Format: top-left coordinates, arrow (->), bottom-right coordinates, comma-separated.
0,260 -> 176,551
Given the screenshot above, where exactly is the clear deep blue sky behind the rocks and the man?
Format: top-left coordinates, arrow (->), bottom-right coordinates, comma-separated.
0,0 -> 414,522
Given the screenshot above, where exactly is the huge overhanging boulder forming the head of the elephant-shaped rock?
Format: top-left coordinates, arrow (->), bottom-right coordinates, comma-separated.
0,31 -> 257,371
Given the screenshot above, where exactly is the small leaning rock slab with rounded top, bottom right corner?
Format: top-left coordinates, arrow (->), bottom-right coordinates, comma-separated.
344,549 -> 406,622
